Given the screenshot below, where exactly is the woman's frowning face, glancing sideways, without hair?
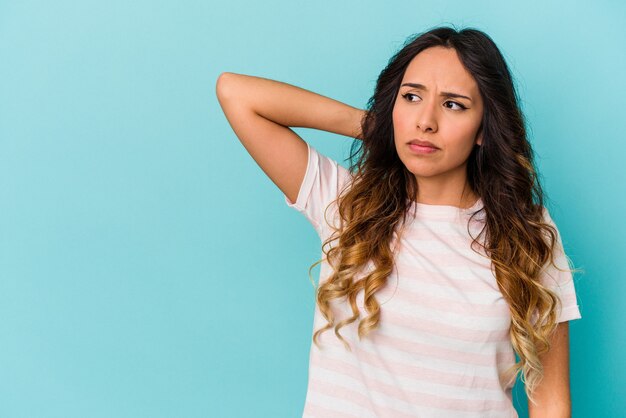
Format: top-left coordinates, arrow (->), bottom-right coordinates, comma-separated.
393,47 -> 483,184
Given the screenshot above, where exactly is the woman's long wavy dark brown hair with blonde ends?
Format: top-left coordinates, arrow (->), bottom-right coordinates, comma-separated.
309,27 -> 580,402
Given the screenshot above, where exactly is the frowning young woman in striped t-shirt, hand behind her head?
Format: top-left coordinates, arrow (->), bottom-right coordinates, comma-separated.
217,27 -> 581,418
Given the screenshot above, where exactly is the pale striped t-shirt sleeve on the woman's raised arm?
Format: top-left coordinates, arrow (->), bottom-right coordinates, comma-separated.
283,143 -> 351,237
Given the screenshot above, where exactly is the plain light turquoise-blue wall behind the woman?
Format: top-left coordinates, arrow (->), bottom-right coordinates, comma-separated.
0,0 -> 626,417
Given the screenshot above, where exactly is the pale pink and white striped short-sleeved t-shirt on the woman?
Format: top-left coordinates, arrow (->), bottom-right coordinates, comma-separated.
285,144 -> 581,418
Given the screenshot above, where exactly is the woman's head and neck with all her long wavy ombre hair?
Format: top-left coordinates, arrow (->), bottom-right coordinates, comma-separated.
312,27 -> 560,400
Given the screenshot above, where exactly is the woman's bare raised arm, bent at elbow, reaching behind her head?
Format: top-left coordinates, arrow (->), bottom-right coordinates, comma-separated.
216,72 -> 365,206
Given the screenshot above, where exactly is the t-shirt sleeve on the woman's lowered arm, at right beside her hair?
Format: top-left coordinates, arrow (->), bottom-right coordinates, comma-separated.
541,207 -> 582,322
